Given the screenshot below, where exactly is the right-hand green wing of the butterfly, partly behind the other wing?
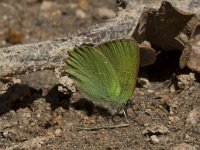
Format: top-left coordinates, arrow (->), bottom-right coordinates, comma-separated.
96,39 -> 139,104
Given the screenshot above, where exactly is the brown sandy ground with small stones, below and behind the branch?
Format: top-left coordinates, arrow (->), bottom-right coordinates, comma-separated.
0,0 -> 200,150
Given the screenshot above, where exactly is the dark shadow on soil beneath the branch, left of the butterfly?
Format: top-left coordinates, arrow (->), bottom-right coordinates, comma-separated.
0,84 -> 70,116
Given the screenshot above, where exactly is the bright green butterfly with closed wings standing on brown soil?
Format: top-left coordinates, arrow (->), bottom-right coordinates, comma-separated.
67,39 -> 140,112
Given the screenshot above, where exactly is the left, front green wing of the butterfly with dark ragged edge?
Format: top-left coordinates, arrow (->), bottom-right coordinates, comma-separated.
67,47 -> 121,102
